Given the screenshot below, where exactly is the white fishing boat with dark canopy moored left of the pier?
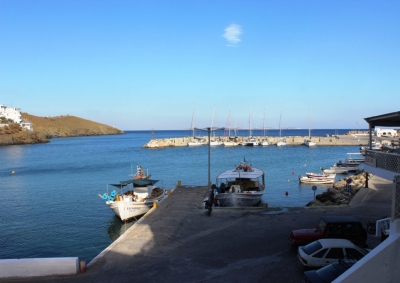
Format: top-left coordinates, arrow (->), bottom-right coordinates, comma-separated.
99,166 -> 165,221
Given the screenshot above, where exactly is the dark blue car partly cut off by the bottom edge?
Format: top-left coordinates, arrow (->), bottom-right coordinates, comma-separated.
303,260 -> 356,283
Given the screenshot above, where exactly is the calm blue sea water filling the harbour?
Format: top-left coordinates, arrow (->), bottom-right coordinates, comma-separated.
0,129 -> 359,262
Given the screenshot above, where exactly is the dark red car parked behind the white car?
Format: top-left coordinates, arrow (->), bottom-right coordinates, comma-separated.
288,216 -> 367,247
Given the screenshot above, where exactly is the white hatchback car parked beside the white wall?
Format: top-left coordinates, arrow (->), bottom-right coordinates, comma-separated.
297,239 -> 369,268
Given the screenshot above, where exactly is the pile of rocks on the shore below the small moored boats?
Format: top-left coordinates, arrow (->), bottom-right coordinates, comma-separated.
306,172 -> 372,206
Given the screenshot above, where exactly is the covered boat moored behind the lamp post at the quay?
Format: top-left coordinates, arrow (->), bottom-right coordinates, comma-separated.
213,158 -> 265,207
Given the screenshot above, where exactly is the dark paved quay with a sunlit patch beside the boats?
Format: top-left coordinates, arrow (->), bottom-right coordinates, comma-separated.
0,177 -> 392,283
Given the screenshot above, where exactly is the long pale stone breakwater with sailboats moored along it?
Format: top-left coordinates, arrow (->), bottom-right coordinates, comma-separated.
143,134 -> 368,148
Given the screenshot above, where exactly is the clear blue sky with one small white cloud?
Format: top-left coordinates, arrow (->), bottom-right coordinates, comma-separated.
0,0 -> 400,131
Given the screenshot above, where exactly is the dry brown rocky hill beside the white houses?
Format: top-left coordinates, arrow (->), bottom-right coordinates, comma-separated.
0,113 -> 124,146
